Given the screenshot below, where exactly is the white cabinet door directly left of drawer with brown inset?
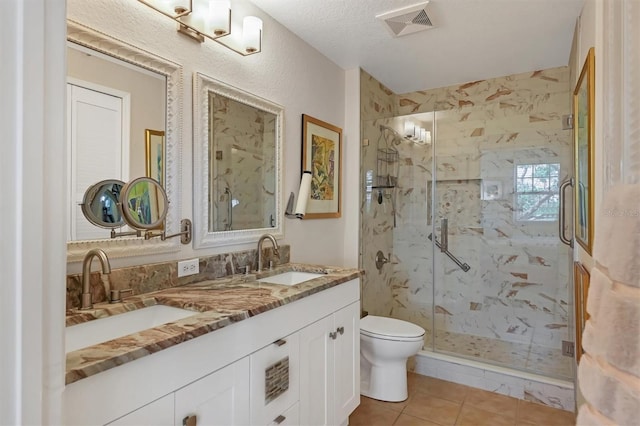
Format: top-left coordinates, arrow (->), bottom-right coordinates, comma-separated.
174,357 -> 249,426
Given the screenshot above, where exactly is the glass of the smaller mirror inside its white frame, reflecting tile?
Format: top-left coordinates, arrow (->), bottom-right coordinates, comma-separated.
209,92 -> 277,232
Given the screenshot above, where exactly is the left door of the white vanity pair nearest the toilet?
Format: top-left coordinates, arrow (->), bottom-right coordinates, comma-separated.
300,316 -> 333,425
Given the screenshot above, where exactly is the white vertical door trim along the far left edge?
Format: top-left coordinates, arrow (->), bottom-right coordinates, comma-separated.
0,0 -> 66,425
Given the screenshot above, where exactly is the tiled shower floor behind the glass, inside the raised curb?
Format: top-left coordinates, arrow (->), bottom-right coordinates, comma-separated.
426,331 -> 573,380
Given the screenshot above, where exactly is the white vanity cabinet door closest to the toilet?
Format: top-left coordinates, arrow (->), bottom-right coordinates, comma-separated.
333,302 -> 360,424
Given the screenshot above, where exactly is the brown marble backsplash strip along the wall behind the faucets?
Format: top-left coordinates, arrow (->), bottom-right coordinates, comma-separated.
66,244 -> 291,309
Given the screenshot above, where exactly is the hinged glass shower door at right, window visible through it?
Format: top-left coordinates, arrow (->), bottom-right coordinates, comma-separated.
431,111 -> 572,378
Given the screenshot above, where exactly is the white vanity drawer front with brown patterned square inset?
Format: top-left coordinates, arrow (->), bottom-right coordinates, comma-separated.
251,332 -> 300,425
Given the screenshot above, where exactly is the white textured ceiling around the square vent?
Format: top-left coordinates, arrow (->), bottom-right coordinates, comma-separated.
251,0 -> 585,93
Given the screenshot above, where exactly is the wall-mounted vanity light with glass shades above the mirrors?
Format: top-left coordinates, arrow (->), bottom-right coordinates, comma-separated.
138,0 -> 262,56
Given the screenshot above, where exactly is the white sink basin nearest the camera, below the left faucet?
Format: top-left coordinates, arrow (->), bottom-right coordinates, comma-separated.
65,305 -> 198,352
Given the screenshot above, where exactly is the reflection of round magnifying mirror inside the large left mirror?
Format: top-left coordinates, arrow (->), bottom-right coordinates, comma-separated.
80,179 -> 124,231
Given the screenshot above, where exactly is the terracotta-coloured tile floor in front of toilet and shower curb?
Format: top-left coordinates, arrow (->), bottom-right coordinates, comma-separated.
349,373 -> 576,426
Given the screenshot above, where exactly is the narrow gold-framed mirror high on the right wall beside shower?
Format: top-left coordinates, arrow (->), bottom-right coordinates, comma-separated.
573,48 -> 595,254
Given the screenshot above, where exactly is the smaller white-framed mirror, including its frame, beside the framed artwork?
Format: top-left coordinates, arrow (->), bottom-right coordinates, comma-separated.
193,73 -> 284,247
